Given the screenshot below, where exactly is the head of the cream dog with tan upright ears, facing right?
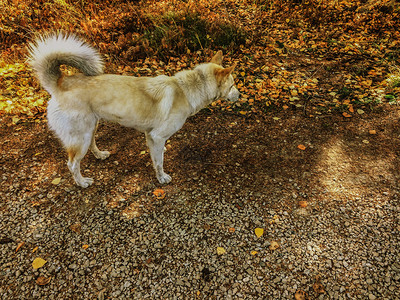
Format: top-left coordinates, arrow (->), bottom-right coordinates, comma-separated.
211,51 -> 240,102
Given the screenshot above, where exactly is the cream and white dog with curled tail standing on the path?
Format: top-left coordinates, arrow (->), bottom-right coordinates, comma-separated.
28,33 -> 240,188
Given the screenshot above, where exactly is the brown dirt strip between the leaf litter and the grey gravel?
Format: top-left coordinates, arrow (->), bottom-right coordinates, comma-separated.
0,106 -> 400,213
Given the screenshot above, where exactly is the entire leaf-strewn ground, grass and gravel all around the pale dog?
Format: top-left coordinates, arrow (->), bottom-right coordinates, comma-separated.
0,0 -> 400,299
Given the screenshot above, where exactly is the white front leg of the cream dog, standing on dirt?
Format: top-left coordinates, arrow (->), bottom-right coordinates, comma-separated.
146,133 -> 172,184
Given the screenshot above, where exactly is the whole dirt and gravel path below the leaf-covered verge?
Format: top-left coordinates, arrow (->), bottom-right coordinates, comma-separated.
0,108 -> 400,299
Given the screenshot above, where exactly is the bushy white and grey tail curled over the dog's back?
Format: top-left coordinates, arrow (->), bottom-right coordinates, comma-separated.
28,33 -> 103,94
